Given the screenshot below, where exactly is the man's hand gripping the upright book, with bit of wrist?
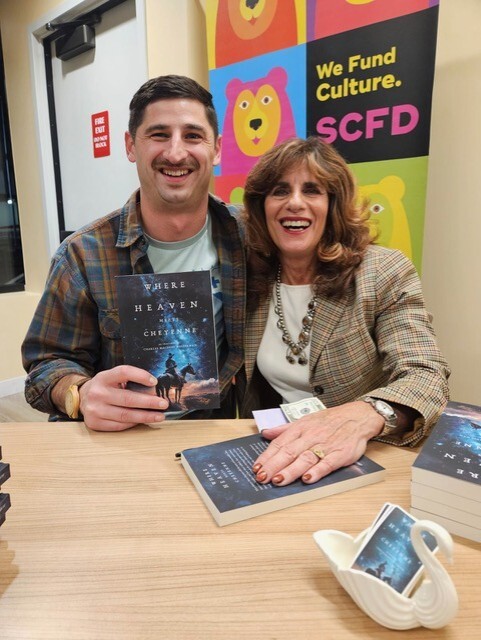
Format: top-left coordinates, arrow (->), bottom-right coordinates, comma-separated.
52,365 -> 169,431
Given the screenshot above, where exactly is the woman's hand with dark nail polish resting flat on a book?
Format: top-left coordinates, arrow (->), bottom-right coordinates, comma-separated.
252,401 -> 384,486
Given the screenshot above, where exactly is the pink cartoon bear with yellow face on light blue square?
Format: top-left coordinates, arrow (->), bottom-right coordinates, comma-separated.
221,67 -> 296,175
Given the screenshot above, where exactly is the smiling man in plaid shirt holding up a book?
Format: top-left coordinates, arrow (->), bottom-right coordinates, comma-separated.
22,75 -> 245,431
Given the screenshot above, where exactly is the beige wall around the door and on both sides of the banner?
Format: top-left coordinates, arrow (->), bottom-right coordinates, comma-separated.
0,0 -> 481,404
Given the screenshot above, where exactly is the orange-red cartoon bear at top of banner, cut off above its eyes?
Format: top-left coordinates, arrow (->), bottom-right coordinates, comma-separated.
215,0 -> 297,67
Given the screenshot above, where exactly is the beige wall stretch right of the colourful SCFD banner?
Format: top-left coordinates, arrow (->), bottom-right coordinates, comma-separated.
422,0 -> 481,404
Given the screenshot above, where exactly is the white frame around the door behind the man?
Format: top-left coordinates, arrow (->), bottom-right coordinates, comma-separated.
28,0 -> 148,256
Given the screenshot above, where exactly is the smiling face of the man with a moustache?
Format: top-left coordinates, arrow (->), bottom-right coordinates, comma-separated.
125,98 -> 221,213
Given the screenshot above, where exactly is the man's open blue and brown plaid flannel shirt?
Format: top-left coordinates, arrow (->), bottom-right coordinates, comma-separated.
22,191 -> 245,415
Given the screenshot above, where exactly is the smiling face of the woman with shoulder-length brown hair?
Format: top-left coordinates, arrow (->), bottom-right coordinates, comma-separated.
264,164 -> 329,260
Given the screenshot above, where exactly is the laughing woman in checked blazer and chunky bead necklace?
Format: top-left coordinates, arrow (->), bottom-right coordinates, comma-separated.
241,137 -> 449,485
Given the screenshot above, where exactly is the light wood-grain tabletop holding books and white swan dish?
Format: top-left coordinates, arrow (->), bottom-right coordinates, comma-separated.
0,420 -> 481,640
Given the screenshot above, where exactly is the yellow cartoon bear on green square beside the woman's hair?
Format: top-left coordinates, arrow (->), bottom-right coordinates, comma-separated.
359,176 -> 412,260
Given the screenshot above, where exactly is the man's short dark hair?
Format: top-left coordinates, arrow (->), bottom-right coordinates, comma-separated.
129,75 -> 219,139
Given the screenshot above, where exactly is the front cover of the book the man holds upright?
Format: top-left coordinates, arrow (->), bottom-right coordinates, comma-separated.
116,271 -> 219,411
